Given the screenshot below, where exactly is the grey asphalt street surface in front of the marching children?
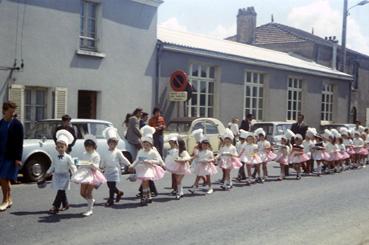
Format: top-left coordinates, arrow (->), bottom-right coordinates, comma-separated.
0,163 -> 369,245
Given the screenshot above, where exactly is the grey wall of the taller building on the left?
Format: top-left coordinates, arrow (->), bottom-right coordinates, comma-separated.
0,0 -> 157,133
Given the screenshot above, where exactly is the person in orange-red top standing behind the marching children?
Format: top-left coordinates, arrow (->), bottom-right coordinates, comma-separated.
149,107 -> 166,156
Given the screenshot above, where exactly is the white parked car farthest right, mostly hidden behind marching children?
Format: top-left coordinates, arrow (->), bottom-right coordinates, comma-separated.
251,122 -> 292,144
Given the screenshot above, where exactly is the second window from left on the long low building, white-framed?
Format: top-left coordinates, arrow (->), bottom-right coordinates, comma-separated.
243,70 -> 266,121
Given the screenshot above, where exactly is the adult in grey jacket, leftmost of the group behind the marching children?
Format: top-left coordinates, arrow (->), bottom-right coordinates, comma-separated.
126,108 -> 142,159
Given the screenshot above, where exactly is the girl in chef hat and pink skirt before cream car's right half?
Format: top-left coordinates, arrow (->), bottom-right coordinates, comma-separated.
189,131 -> 217,194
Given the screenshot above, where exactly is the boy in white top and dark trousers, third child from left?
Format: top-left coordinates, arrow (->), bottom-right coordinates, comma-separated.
100,127 -> 131,207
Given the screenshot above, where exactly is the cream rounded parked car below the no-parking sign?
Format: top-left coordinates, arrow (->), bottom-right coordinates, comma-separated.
164,117 -> 225,154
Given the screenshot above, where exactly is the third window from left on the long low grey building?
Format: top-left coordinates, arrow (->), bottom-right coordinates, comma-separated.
286,77 -> 304,122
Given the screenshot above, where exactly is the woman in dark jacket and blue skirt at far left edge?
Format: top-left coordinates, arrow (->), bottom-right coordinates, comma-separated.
0,101 -> 23,211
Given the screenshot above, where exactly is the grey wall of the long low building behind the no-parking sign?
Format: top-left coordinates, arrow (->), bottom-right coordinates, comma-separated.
159,48 -> 349,127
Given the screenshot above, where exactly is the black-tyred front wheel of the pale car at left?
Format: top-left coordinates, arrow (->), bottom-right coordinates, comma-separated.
23,156 -> 50,182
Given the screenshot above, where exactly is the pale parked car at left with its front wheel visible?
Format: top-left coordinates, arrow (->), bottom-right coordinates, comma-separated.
21,119 -> 132,181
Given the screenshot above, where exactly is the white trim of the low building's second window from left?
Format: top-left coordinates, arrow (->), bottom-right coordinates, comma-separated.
242,70 -> 266,120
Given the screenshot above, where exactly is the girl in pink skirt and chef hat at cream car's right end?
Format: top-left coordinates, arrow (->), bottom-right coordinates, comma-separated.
217,128 -> 242,190
